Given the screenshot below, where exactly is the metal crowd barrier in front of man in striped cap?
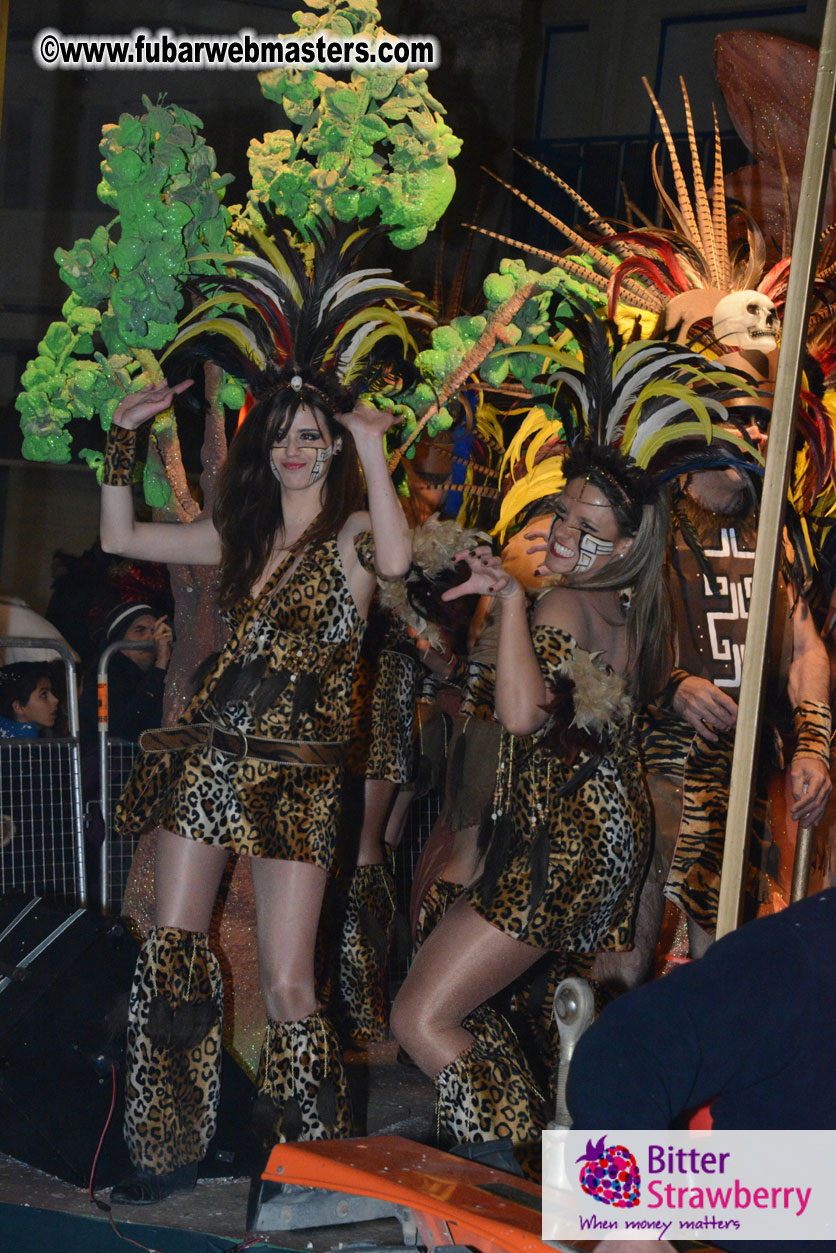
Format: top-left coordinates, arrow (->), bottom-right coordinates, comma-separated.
97,639 -> 154,913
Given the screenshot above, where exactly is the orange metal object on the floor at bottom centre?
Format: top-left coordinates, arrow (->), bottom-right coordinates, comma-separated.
262,1135 -> 549,1253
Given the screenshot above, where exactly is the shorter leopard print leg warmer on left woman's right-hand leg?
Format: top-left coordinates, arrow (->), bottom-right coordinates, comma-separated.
253,1014 -> 352,1148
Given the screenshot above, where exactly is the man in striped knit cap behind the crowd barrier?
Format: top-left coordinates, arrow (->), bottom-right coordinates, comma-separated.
79,601 -> 173,742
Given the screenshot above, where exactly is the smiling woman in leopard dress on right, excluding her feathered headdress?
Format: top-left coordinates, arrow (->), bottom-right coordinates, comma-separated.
392,441 -> 669,1143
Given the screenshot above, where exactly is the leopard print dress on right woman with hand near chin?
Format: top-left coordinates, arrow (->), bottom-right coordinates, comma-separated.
466,625 -> 651,954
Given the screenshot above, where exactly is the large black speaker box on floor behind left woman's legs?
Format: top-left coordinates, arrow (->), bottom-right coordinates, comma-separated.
0,897 -> 259,1188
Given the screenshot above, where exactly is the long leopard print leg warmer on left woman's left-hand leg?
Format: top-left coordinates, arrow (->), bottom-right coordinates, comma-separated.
124,927 -> 223,1183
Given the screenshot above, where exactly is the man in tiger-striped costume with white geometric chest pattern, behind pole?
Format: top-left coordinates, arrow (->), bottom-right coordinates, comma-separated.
637,469 -> 831,960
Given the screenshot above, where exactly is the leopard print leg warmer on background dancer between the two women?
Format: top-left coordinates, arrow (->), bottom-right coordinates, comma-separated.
340,862 -> 395,1044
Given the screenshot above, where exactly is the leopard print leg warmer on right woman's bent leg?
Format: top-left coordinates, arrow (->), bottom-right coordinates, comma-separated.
435,1006 -> 546,1148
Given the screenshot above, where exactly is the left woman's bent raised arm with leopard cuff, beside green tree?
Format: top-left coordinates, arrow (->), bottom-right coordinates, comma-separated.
99,380 -> 221,565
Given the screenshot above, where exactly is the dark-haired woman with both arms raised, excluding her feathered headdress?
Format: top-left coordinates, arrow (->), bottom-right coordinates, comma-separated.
102,377 -> 411,1204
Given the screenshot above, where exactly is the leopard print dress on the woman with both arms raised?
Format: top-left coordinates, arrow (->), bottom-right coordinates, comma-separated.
117,533 -> 372,870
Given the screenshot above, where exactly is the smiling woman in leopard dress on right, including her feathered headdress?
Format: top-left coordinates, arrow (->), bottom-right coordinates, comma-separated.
391,300 -> 757,1163
